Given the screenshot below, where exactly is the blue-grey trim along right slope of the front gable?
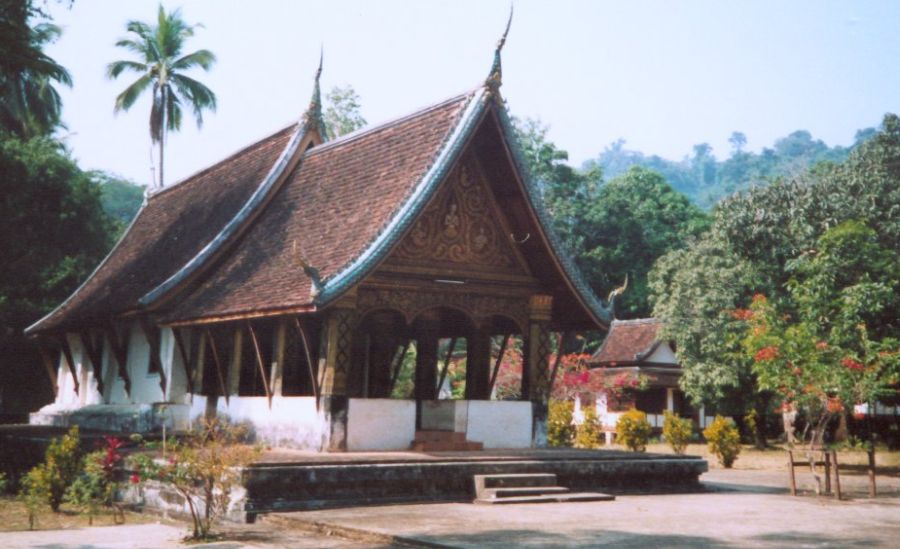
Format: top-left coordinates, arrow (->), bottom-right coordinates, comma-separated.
495,96 -> 615,327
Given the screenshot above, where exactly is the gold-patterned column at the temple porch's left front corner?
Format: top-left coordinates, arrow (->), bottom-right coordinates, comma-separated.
319,292 -> 357,452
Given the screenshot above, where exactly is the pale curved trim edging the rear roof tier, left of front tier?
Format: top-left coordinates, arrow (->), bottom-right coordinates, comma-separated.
138,123 -> 309,307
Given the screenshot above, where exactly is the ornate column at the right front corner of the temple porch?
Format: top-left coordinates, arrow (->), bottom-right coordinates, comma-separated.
522,295 -> 553,448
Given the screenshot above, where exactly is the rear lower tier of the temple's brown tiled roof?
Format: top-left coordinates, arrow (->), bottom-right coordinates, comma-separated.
29,126 -> 295,333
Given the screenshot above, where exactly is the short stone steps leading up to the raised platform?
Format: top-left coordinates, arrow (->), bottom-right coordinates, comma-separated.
473,473 -> 615,505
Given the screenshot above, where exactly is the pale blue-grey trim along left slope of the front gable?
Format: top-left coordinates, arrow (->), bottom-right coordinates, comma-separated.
315,88 -> 488,306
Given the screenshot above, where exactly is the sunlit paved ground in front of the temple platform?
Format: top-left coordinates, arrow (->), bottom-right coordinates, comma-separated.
269,470 -> 900,548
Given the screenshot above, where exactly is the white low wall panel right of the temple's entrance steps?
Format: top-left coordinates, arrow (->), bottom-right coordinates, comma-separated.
464,400 -> 532,448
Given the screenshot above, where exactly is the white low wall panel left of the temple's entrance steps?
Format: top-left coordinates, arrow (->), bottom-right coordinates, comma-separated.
347,398 -> 416,452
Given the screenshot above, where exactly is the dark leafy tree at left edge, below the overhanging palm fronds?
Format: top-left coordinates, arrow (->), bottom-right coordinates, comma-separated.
0,138 -> 112,411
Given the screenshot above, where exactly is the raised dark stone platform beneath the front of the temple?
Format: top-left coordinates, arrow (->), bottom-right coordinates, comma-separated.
244,449 -> 708,519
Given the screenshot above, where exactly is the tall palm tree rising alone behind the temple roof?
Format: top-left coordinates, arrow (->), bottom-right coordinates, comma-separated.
106,5 -> 216,188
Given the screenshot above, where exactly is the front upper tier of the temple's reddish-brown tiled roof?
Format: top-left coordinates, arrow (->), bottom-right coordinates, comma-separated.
164,94 -> 472,322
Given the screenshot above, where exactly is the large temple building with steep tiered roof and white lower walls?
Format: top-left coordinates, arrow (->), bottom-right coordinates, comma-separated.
27,37 -> 613,451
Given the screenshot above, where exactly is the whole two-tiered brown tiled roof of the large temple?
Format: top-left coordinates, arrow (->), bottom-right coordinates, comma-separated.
28,40 -> 612,334
